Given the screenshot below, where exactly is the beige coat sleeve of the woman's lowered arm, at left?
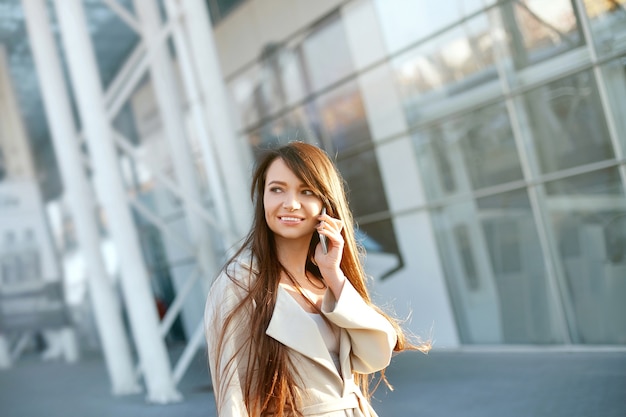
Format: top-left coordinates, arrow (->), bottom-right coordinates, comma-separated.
204,264 -> 248,417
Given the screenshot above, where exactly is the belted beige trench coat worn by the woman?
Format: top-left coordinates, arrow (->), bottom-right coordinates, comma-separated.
205,254 -> 397,417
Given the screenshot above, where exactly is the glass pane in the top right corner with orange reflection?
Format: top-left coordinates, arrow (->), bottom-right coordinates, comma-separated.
583,0 -> 626,56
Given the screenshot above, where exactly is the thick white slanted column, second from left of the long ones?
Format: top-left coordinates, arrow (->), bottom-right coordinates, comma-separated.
55,0 -> 181,403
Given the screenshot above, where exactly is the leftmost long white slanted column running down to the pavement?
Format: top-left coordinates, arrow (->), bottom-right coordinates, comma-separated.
23,0 -> 141,395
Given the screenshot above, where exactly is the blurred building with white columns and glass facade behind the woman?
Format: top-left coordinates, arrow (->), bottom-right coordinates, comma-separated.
0,0 -> 626,401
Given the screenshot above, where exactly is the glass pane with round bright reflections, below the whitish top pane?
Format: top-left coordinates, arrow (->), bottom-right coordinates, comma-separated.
392,14 -> 497,124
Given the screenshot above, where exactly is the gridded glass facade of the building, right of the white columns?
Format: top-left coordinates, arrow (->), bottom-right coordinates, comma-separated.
217,0 -> 626,344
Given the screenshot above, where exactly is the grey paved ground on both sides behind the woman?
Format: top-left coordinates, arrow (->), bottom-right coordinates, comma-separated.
0,349 -> 626,417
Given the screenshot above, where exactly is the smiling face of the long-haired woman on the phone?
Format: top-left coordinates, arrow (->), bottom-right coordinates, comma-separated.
263,158 -> 322,244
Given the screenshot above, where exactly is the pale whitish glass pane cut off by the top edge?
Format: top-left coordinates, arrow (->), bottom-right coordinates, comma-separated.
374,0 -> 494,53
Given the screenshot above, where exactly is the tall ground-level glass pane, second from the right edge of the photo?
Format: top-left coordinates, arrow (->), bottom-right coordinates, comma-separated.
476,190 -> 562,343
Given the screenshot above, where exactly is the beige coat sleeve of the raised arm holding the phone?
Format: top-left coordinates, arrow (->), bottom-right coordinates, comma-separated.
322,280 -> 397,374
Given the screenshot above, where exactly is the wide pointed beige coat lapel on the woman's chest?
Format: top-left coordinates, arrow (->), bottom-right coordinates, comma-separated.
265,286 -> 339,376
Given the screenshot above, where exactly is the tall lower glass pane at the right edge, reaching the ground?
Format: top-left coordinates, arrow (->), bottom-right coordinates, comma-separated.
546,168 -> 626,344
